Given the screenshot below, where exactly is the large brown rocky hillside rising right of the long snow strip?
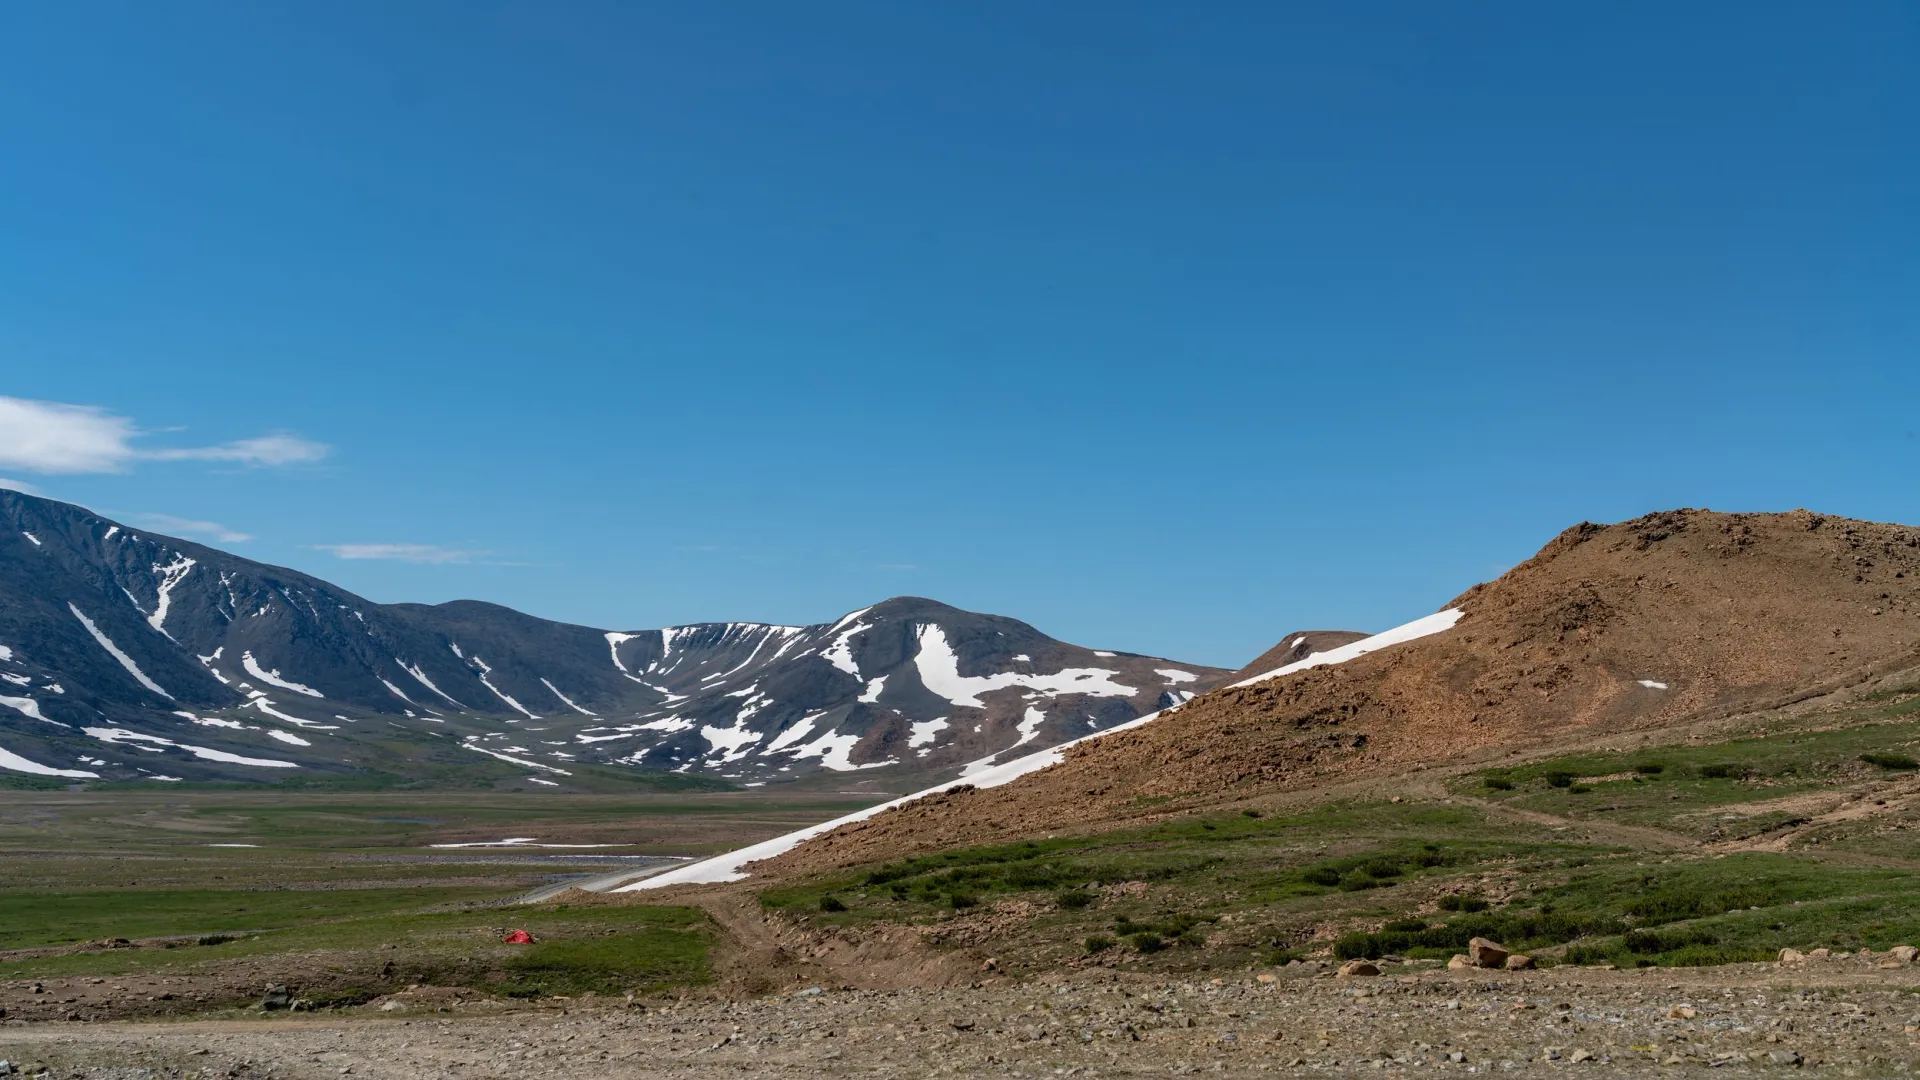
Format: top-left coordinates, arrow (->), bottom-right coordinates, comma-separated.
764,509 -> 1920,872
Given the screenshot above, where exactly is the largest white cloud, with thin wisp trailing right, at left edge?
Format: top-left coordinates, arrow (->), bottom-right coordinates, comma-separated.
0,396 -> 328,473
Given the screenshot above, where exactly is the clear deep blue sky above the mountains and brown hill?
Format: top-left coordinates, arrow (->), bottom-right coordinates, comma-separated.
0,0 -> 1920,665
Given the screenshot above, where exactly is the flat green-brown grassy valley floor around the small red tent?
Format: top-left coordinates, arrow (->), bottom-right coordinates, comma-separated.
0,790 -> 872,1007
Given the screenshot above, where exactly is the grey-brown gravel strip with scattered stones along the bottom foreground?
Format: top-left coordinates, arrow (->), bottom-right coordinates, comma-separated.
0,965 -> 1920,1080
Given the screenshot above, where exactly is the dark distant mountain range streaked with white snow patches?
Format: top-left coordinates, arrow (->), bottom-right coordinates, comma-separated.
0,490 -> 1225,786
